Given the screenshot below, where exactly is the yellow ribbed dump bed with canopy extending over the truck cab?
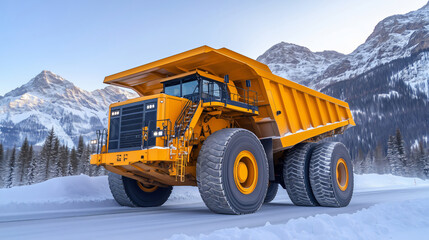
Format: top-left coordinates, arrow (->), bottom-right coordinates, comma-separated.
104,46 -> 355,152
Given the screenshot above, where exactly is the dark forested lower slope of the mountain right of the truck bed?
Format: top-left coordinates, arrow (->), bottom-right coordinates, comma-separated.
322,52 -> 429,157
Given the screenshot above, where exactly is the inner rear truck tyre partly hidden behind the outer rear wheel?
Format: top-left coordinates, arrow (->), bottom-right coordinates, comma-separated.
283,143 -> 319,206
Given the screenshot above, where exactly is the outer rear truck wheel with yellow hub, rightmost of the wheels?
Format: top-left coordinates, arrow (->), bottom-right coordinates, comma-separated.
310,142 -> 353,207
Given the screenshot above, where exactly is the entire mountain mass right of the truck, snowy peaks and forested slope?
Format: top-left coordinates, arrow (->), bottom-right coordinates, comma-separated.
257,3 -> 429,158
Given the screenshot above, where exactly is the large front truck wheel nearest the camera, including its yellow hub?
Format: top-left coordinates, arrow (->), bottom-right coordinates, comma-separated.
197,128 -> 269,214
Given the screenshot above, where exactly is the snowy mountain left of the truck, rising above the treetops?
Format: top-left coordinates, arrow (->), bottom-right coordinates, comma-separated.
0,71 -> 137,148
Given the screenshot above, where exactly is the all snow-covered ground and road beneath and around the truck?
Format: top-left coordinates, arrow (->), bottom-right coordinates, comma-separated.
0,174 -> 429,239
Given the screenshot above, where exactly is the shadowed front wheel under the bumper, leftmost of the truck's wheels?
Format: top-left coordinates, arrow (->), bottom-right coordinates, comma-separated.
108,172 -> 173,207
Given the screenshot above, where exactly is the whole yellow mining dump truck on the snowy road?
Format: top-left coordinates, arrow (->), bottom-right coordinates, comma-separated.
91,46 -> 355,214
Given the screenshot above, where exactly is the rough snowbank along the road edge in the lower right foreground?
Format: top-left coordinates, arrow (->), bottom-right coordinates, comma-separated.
170,199 -> 429,240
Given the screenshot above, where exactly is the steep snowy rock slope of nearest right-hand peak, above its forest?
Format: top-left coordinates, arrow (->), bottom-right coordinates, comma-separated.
313,3 -> 429,89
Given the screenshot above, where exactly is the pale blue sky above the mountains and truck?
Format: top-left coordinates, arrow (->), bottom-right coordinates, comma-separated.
0,0 -> 427,95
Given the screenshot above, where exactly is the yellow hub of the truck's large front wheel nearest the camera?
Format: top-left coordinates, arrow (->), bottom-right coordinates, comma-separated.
234,150 -> 258,194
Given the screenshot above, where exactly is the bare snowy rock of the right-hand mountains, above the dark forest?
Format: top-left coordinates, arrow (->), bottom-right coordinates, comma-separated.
257,3 -> 429,94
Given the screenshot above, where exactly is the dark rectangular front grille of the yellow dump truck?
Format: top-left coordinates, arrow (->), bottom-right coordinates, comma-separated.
109,99 -> 157,152
